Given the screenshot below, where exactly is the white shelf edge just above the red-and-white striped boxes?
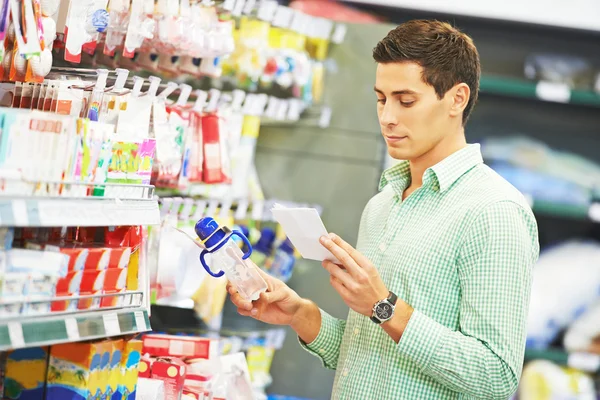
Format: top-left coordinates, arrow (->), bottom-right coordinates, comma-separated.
0,197 -> 160,227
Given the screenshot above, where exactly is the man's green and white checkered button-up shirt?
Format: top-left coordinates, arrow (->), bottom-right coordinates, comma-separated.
305,145 -> 539,400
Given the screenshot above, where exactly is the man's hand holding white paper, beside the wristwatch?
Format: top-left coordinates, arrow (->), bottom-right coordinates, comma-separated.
321,233 -> 389,317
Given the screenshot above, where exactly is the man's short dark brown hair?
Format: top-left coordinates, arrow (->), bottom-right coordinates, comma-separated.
373,20 -> 481,125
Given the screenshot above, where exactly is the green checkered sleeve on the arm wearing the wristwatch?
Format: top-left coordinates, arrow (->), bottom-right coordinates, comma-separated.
397,201 -> 539,399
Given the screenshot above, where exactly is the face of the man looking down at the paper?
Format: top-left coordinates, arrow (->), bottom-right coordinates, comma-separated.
375,62 -> 452,160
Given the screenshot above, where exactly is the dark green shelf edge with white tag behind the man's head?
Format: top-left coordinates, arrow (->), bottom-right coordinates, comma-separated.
479,75 -> 600,107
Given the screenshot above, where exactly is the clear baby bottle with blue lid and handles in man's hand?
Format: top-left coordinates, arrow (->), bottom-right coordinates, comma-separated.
195,217 -> 267,301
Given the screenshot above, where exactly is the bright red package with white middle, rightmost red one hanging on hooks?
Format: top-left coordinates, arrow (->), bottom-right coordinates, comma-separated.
202,114 -> 225,183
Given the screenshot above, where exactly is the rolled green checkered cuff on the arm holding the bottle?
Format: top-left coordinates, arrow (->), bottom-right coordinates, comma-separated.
298,309 -> 343,368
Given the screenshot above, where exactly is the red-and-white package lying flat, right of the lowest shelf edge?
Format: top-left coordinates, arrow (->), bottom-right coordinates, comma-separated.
142,334 -> 219,360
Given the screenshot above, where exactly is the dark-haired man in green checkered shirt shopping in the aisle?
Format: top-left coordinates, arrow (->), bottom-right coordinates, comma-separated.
229,21 -> 539,400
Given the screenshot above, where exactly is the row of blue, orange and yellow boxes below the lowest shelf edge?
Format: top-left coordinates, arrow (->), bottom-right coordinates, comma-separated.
0,339 -> 142,400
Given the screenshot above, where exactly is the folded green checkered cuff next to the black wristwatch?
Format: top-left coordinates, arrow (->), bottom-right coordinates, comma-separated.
398,310 -> 448,370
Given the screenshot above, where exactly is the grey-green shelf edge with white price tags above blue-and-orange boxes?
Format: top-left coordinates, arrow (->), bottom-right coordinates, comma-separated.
0,308 -> 151,351
